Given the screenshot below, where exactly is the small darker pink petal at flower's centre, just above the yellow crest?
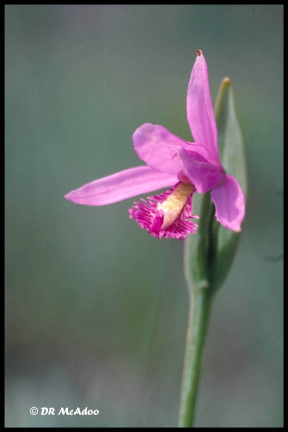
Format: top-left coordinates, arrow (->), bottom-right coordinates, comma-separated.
178,149 -> 224,193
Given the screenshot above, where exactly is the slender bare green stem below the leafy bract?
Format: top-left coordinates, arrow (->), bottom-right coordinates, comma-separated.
179,287 -> 212,427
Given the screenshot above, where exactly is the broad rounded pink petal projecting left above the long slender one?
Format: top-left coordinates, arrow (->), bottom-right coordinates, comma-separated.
133,123 -> 209,175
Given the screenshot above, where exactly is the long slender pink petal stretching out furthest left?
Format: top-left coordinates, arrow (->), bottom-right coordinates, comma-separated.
65,166 -> 178,206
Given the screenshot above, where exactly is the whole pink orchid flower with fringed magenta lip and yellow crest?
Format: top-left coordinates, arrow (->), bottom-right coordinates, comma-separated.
65,50 -> 245,239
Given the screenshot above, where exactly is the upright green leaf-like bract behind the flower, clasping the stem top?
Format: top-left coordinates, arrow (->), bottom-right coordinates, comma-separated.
184,78 -> 247,294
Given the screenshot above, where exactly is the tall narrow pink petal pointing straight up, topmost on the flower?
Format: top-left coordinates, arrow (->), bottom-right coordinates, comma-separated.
187,50 -> 220,165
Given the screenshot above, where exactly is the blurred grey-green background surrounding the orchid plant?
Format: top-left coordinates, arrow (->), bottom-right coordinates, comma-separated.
5,5 -> 283,427
